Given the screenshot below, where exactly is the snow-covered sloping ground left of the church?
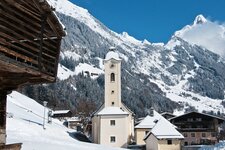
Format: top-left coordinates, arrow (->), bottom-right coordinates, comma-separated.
7,91 -> 124,150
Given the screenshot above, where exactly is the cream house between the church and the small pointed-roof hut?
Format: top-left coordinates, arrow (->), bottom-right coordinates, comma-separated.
134,110 -> 162,145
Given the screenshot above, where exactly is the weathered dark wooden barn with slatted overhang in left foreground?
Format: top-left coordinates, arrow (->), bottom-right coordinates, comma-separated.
0,0 -> 65,149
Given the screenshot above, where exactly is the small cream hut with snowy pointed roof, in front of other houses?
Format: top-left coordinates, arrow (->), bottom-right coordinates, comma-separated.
144,118 -> 184,150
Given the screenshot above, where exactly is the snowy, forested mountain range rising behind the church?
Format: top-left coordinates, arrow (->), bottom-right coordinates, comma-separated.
22,0 -> 225,116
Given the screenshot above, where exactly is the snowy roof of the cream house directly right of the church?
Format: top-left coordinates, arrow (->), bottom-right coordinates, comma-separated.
135,110 -> 163,129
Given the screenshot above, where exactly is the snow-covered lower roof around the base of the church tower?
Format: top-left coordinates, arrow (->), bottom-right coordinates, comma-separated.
96,107 -> 129,115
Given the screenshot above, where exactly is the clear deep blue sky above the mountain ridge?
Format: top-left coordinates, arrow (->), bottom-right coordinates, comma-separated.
70,0 -> 225,43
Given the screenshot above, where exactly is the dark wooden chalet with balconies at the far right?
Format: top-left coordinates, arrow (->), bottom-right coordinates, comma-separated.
170,112 -> 224,145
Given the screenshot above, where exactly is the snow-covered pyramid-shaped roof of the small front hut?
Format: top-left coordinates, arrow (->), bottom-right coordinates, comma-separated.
144,118 -> 184,140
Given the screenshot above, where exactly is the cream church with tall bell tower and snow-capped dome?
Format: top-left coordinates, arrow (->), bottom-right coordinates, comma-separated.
92,47 -> 134,148
